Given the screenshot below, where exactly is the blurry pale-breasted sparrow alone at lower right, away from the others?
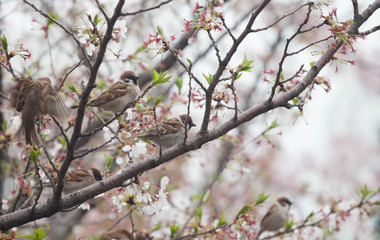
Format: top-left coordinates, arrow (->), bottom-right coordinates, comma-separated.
256,197 -> 293,239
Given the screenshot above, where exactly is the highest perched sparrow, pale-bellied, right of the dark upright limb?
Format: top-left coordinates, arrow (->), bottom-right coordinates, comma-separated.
87,71 -> 140,113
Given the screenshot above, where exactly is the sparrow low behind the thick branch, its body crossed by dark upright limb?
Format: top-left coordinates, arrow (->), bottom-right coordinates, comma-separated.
43,168 -> 102,194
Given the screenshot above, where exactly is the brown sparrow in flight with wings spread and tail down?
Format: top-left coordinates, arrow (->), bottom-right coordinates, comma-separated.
10,77 -> 67,147
